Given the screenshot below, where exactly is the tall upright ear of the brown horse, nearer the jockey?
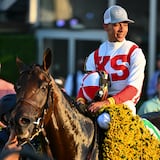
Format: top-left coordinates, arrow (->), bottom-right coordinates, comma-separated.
43,48 -> 52,71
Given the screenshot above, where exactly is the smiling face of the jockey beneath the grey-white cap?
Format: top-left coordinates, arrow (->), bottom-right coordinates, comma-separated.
104,22 -> 128,42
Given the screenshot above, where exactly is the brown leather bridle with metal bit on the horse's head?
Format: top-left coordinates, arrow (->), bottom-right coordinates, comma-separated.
12,65 -> 53,158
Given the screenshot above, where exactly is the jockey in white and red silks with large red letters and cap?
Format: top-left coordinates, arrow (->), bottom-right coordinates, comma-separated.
81,5 -> 146,114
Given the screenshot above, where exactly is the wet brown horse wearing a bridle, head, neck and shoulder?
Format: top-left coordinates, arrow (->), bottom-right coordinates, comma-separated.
10,49 -> 98,160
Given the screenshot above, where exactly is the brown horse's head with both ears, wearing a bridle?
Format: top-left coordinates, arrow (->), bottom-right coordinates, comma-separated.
10,49 -> 51,143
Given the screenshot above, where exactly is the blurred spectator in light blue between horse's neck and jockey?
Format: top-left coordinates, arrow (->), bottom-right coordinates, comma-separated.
64,59 -> 84,97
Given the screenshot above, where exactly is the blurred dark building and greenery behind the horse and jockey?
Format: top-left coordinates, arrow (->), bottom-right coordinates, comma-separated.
0,0 -> 160,101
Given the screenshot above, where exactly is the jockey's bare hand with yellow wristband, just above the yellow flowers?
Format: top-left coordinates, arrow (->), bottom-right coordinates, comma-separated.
88,100 -> 110,113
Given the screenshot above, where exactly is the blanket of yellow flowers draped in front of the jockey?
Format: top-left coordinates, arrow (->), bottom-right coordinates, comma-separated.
102,104 -> 160,160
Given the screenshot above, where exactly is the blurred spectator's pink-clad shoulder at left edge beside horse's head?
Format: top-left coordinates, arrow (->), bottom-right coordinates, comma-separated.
0,64 -> 16,99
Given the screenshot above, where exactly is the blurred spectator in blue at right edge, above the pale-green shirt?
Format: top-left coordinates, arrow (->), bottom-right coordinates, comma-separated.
147,54 -> 160,98
